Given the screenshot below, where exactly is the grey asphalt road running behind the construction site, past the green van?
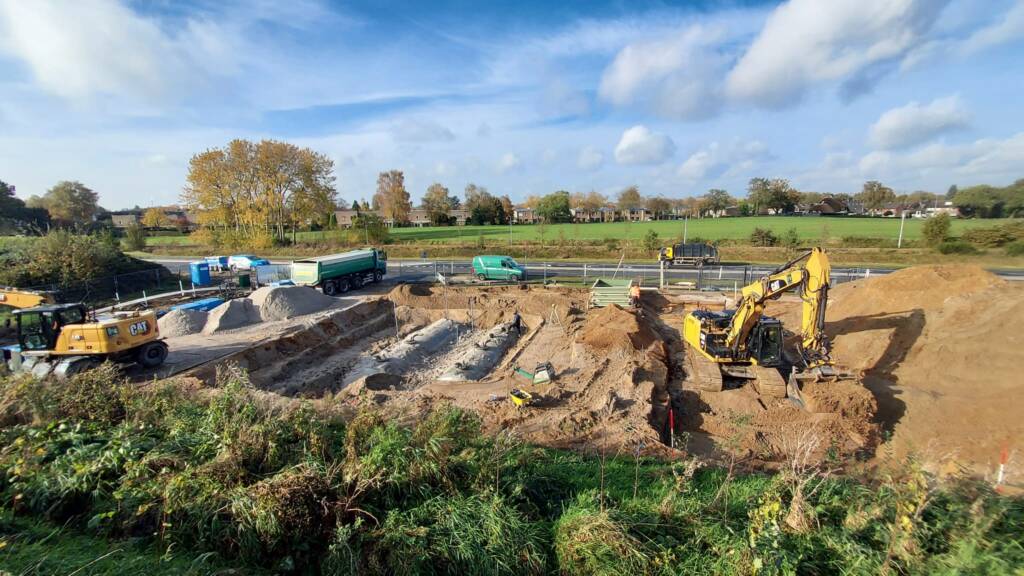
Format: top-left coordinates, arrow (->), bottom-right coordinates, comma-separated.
142,257 -> 1024,288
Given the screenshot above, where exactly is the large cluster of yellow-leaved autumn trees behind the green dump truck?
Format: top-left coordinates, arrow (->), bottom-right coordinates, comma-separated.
181,139 -> 337,239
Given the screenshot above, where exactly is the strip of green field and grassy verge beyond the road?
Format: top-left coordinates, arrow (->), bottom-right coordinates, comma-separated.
138,216 -> 1024,268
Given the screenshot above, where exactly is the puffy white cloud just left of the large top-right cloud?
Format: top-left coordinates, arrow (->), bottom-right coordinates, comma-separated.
598,26 -> 728,119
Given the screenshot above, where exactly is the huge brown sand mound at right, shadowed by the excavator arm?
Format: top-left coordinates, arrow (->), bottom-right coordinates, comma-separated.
770,265 -> 1024,471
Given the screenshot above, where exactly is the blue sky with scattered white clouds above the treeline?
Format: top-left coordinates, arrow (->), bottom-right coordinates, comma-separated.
0,0 -> 1024,209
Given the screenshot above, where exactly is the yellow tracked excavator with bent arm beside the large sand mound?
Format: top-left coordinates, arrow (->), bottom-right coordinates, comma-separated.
683,248 -> 851,404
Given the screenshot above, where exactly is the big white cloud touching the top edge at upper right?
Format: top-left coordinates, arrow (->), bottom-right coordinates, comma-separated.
726,0 -> 946,108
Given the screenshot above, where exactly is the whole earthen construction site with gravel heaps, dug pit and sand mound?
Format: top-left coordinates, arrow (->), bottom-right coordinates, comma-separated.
59,251 -> 1011,477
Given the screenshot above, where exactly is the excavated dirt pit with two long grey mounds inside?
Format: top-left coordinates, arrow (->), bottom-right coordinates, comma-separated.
182,285 -> 877,460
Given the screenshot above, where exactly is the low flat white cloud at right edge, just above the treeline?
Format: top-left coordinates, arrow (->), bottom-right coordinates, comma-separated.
859,132 -> 1024,181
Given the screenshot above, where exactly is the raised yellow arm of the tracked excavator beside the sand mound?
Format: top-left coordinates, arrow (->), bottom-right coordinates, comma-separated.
725,248 -> 830,367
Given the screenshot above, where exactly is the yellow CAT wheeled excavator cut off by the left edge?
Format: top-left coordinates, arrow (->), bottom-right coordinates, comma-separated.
0,287 -> 167,377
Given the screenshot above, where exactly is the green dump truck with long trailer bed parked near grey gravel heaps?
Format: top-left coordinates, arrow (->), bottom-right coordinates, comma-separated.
292,248 -> 387,296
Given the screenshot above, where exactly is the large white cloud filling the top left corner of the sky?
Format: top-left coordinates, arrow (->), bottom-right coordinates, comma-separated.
0,0 -> 234,99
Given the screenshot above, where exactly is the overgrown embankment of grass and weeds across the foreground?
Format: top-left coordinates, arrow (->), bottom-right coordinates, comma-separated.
0,369 -> 1024,575
